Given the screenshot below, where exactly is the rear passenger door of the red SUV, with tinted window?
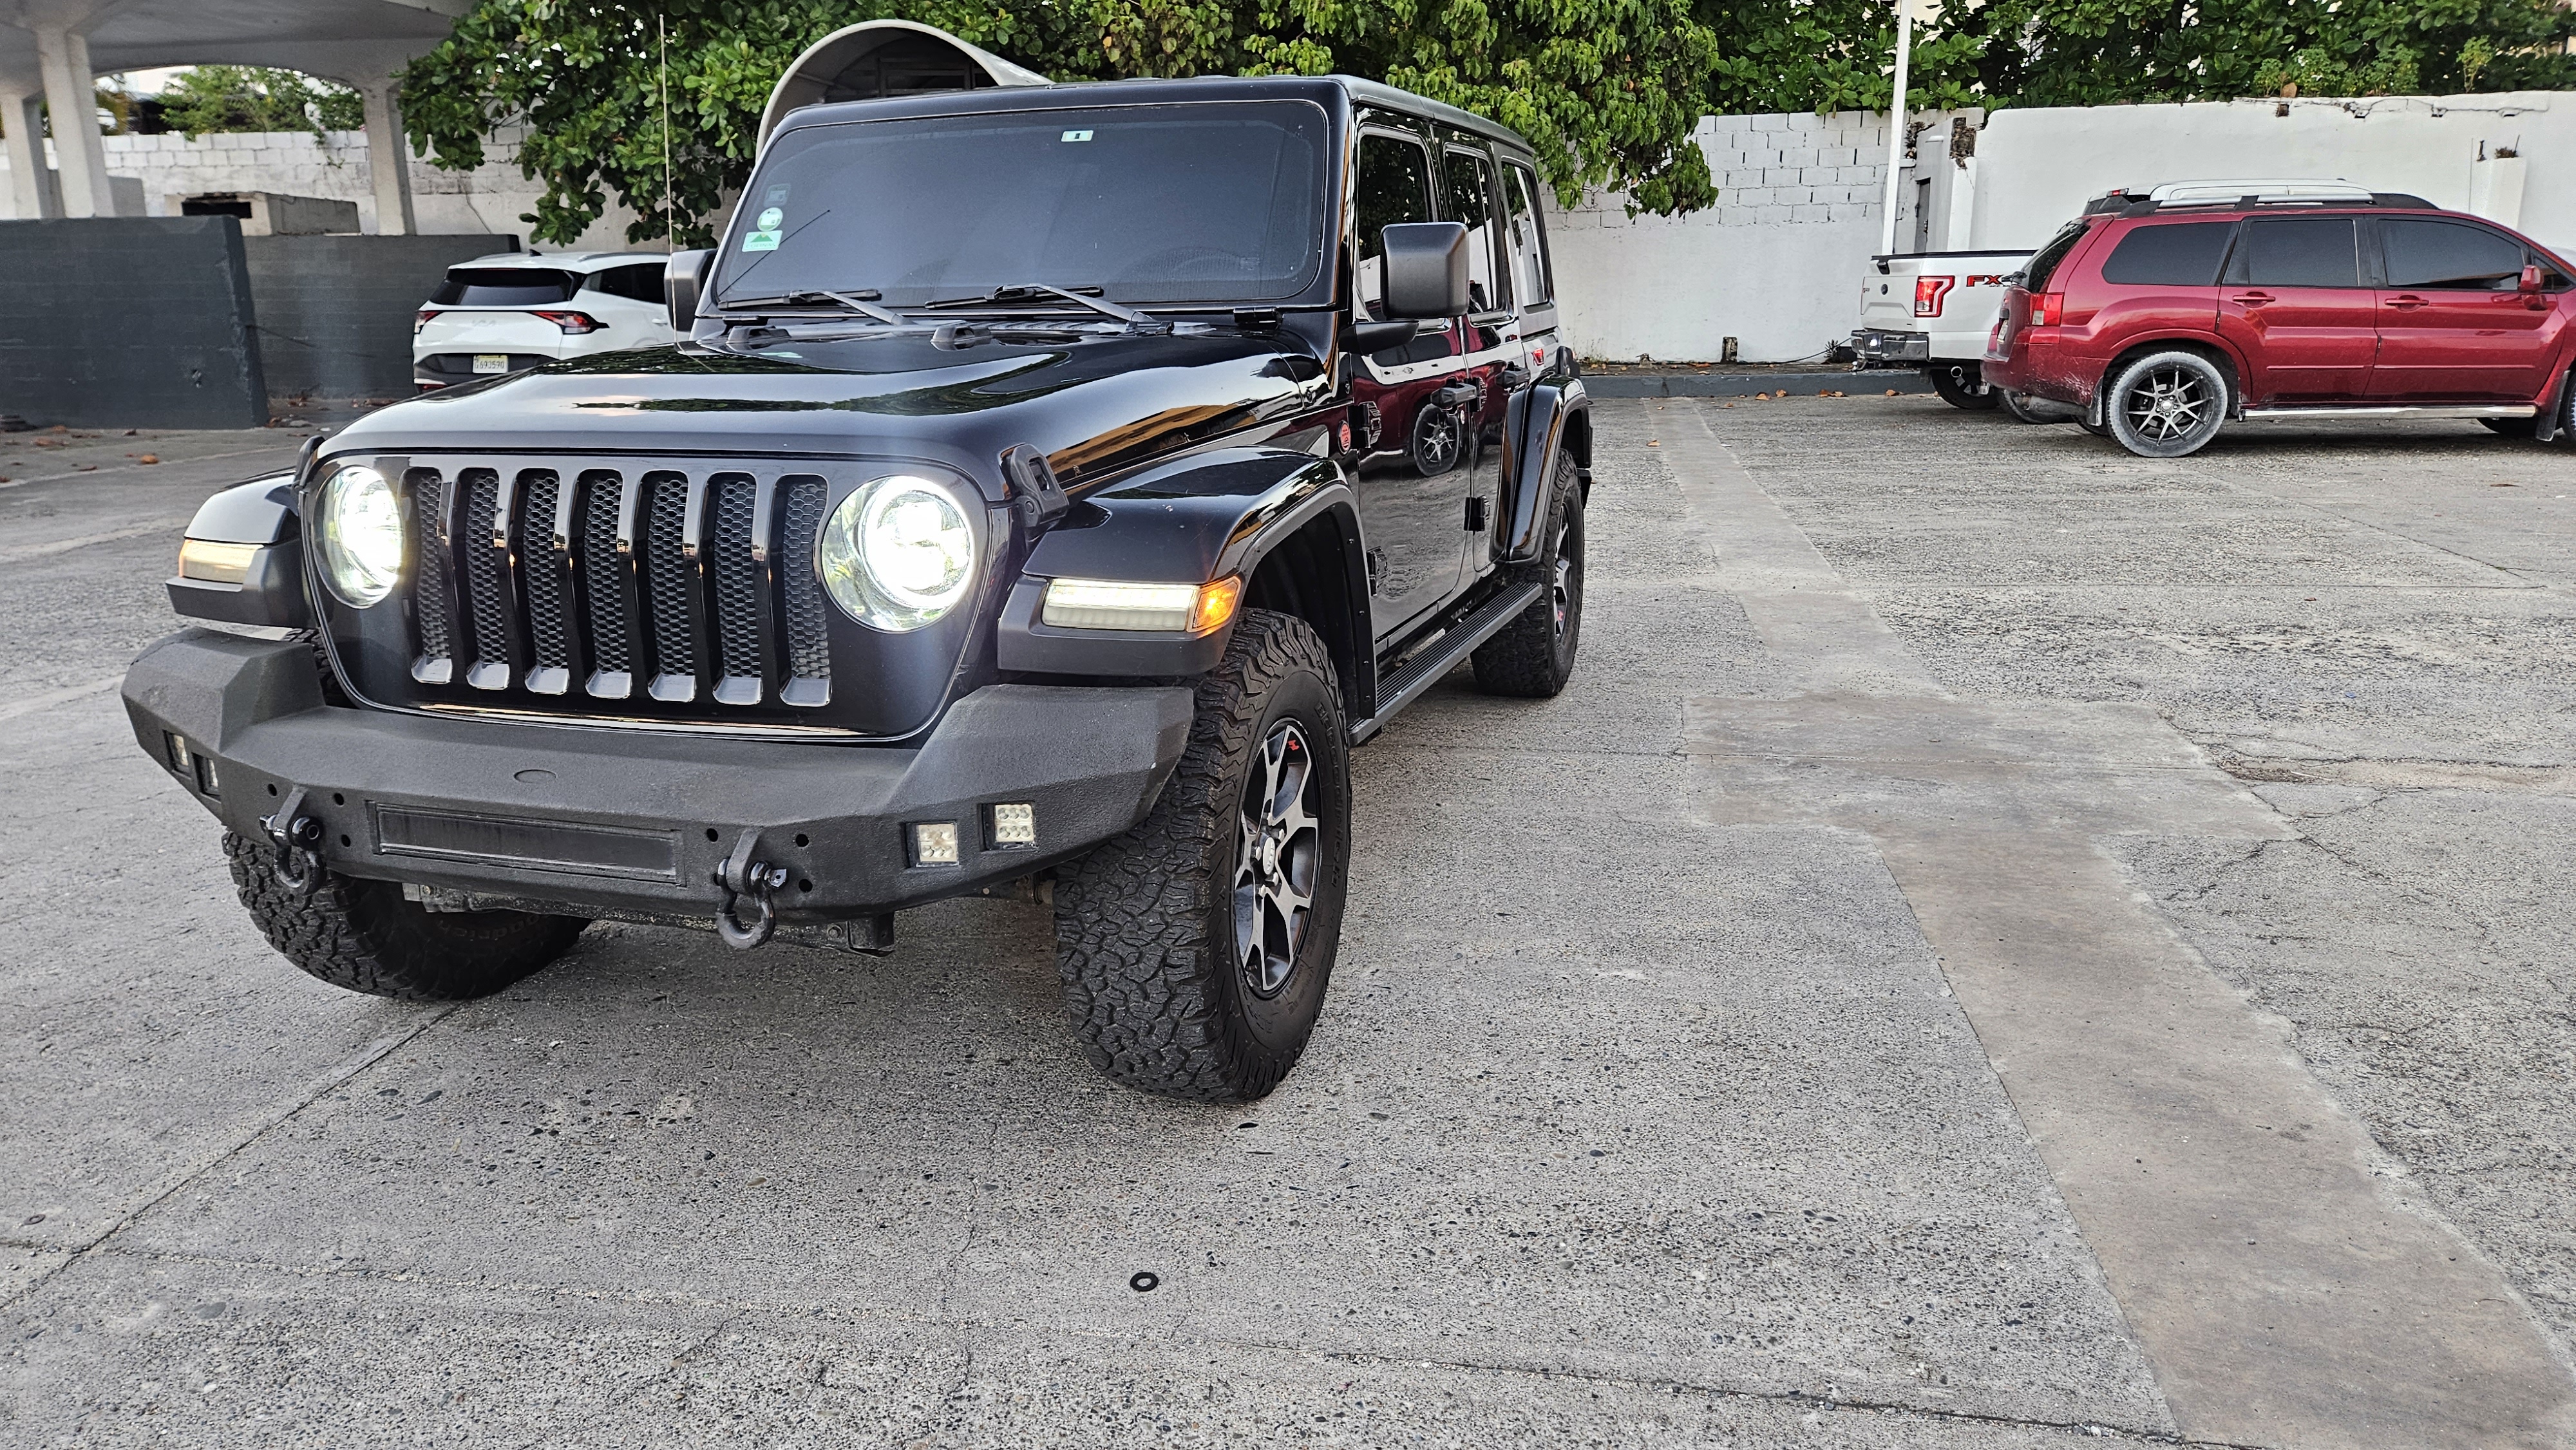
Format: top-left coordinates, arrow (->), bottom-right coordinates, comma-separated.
2218,216 -> 2380,402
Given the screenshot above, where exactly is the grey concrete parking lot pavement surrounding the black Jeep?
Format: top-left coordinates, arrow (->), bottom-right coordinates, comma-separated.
0,397 -> 2576,1447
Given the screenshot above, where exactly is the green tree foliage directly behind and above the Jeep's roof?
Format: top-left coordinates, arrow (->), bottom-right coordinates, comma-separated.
402,0 -> 1718,245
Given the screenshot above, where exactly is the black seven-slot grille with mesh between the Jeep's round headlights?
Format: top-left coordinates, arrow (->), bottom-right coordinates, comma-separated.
374,458 -> 835,724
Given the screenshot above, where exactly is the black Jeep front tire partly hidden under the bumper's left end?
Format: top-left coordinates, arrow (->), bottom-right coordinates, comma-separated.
224,832 -> 590,1002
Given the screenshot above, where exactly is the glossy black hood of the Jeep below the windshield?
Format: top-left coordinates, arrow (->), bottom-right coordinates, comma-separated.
327,325 -> 1324,487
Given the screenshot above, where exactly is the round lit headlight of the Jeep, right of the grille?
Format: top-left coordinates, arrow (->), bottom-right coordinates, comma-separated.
814,474 -> 974,634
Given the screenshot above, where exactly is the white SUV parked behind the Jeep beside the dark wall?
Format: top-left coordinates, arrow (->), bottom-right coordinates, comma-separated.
412,252 -> 680,391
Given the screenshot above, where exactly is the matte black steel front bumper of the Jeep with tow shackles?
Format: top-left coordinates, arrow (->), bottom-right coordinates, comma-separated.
124,631 -> 1193,927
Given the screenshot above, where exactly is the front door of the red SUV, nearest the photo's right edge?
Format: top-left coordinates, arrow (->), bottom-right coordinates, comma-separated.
2370,216 -> 2558,402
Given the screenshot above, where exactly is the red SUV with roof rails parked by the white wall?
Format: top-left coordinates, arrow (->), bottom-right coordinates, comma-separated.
1986,180 -> 2576,458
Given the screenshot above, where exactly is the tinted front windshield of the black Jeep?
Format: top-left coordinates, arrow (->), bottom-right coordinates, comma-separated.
716,100 -> 1327,306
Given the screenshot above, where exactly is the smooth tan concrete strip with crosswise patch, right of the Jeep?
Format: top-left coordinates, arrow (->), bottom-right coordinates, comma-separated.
1662,402 -> 2576,1447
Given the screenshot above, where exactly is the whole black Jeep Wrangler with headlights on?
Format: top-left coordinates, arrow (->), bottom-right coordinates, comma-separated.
124,77 -> 1592,1100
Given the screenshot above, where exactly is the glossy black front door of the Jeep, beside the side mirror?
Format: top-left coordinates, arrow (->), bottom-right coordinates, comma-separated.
1350,129 -> 1476,641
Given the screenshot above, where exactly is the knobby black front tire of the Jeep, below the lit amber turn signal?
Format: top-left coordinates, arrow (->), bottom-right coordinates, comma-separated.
1056,610 -> 1350,1102
